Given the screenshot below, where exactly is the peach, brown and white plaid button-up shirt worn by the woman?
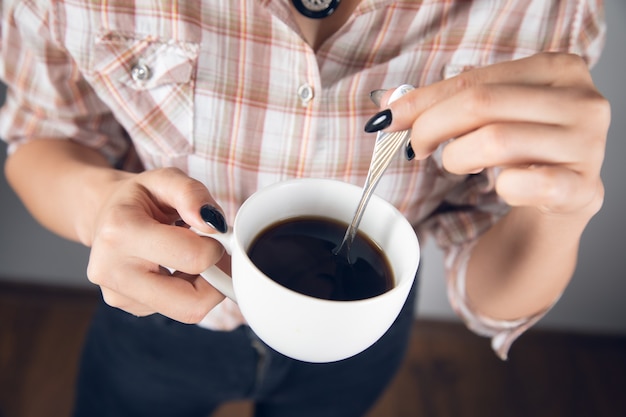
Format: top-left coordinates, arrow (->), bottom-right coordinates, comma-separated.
0,0 -> 604,357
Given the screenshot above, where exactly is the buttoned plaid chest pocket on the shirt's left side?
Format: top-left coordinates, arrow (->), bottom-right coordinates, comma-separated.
91,32 -> 199,158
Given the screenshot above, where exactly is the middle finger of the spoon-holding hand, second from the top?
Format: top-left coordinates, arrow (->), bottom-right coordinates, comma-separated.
411,85 -> 590,159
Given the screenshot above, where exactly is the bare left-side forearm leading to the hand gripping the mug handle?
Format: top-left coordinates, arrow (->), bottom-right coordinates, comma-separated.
5,140 -> 128,246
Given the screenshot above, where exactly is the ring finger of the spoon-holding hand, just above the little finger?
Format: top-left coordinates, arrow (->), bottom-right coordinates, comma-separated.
442,123 -> 576,175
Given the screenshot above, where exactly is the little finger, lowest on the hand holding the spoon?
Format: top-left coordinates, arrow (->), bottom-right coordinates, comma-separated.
496,166 -> 595,213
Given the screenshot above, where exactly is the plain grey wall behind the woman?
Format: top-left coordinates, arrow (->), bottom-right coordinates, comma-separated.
0,0 -> 626,335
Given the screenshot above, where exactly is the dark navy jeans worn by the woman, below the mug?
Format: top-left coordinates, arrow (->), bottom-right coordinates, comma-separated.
74,280 -> 417,417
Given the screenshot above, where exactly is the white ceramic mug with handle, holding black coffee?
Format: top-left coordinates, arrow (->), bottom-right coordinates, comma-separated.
196,179 -> 420,362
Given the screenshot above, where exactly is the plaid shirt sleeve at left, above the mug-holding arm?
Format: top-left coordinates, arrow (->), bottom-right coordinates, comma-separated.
0,2 -> 131,164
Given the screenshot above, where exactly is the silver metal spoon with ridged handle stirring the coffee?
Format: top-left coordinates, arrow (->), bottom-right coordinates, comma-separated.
333,85 -> 413,262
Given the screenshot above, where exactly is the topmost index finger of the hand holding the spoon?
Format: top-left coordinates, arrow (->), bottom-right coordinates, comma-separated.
381,53 -> 594,131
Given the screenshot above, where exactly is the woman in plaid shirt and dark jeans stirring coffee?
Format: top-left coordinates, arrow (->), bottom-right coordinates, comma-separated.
0,0 -> 610,416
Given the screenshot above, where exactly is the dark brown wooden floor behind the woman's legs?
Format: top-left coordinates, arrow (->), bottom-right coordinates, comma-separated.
0,283 -> 626,417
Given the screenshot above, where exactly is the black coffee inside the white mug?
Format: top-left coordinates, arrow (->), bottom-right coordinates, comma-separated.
248,217 -> 394,301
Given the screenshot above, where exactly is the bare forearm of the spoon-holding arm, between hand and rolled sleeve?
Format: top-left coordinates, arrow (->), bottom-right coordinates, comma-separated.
466,207 -> 591,320
